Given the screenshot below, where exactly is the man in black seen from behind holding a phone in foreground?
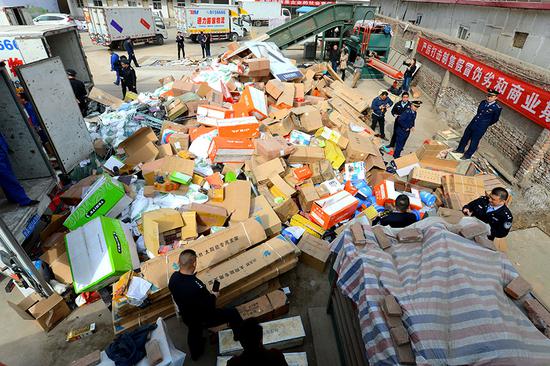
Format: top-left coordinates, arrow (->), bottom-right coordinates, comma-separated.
168,249 -> 242,360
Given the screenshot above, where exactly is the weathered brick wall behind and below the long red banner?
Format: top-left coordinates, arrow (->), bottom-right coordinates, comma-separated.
380,16 -> 550,186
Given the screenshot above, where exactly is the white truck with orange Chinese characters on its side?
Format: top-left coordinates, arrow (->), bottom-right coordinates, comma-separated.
175,4 -> 252,42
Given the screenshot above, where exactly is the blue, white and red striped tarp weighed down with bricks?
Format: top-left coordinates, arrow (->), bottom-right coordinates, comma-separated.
332,219 -> 550,365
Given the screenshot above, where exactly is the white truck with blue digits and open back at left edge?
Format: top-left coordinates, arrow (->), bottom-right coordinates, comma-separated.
0,25 -> 93,88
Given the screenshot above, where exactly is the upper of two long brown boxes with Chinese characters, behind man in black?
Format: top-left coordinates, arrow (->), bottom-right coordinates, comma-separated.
141,219 -> 266,288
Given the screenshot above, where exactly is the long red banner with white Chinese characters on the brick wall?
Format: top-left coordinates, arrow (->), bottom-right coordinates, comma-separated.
416,38 -> 550,129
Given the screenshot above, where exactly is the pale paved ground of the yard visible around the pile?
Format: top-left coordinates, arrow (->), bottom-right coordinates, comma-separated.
0,25 -> 550,366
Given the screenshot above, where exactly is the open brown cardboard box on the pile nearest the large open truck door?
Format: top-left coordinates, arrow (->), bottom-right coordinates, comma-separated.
118,127 -> 159,167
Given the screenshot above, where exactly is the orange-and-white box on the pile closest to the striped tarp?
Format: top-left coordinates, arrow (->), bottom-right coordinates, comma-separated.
311,191 -> 359,229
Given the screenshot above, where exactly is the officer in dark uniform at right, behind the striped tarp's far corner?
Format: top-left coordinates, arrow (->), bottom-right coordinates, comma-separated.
462,187 -> 514,240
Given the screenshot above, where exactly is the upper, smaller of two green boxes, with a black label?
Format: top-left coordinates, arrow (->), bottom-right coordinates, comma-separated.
63,174 -> 129,230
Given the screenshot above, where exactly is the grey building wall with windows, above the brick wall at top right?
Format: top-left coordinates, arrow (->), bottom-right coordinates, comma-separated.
371,0 -> 550,68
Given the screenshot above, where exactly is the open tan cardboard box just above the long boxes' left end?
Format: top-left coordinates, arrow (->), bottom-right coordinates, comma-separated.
141,208 -> 198,256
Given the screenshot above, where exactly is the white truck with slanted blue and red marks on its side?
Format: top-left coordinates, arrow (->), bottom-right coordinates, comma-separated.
84,6 -> 168,49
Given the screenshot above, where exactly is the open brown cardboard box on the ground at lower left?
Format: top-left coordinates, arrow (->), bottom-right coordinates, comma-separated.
8,293 -> 71,331
